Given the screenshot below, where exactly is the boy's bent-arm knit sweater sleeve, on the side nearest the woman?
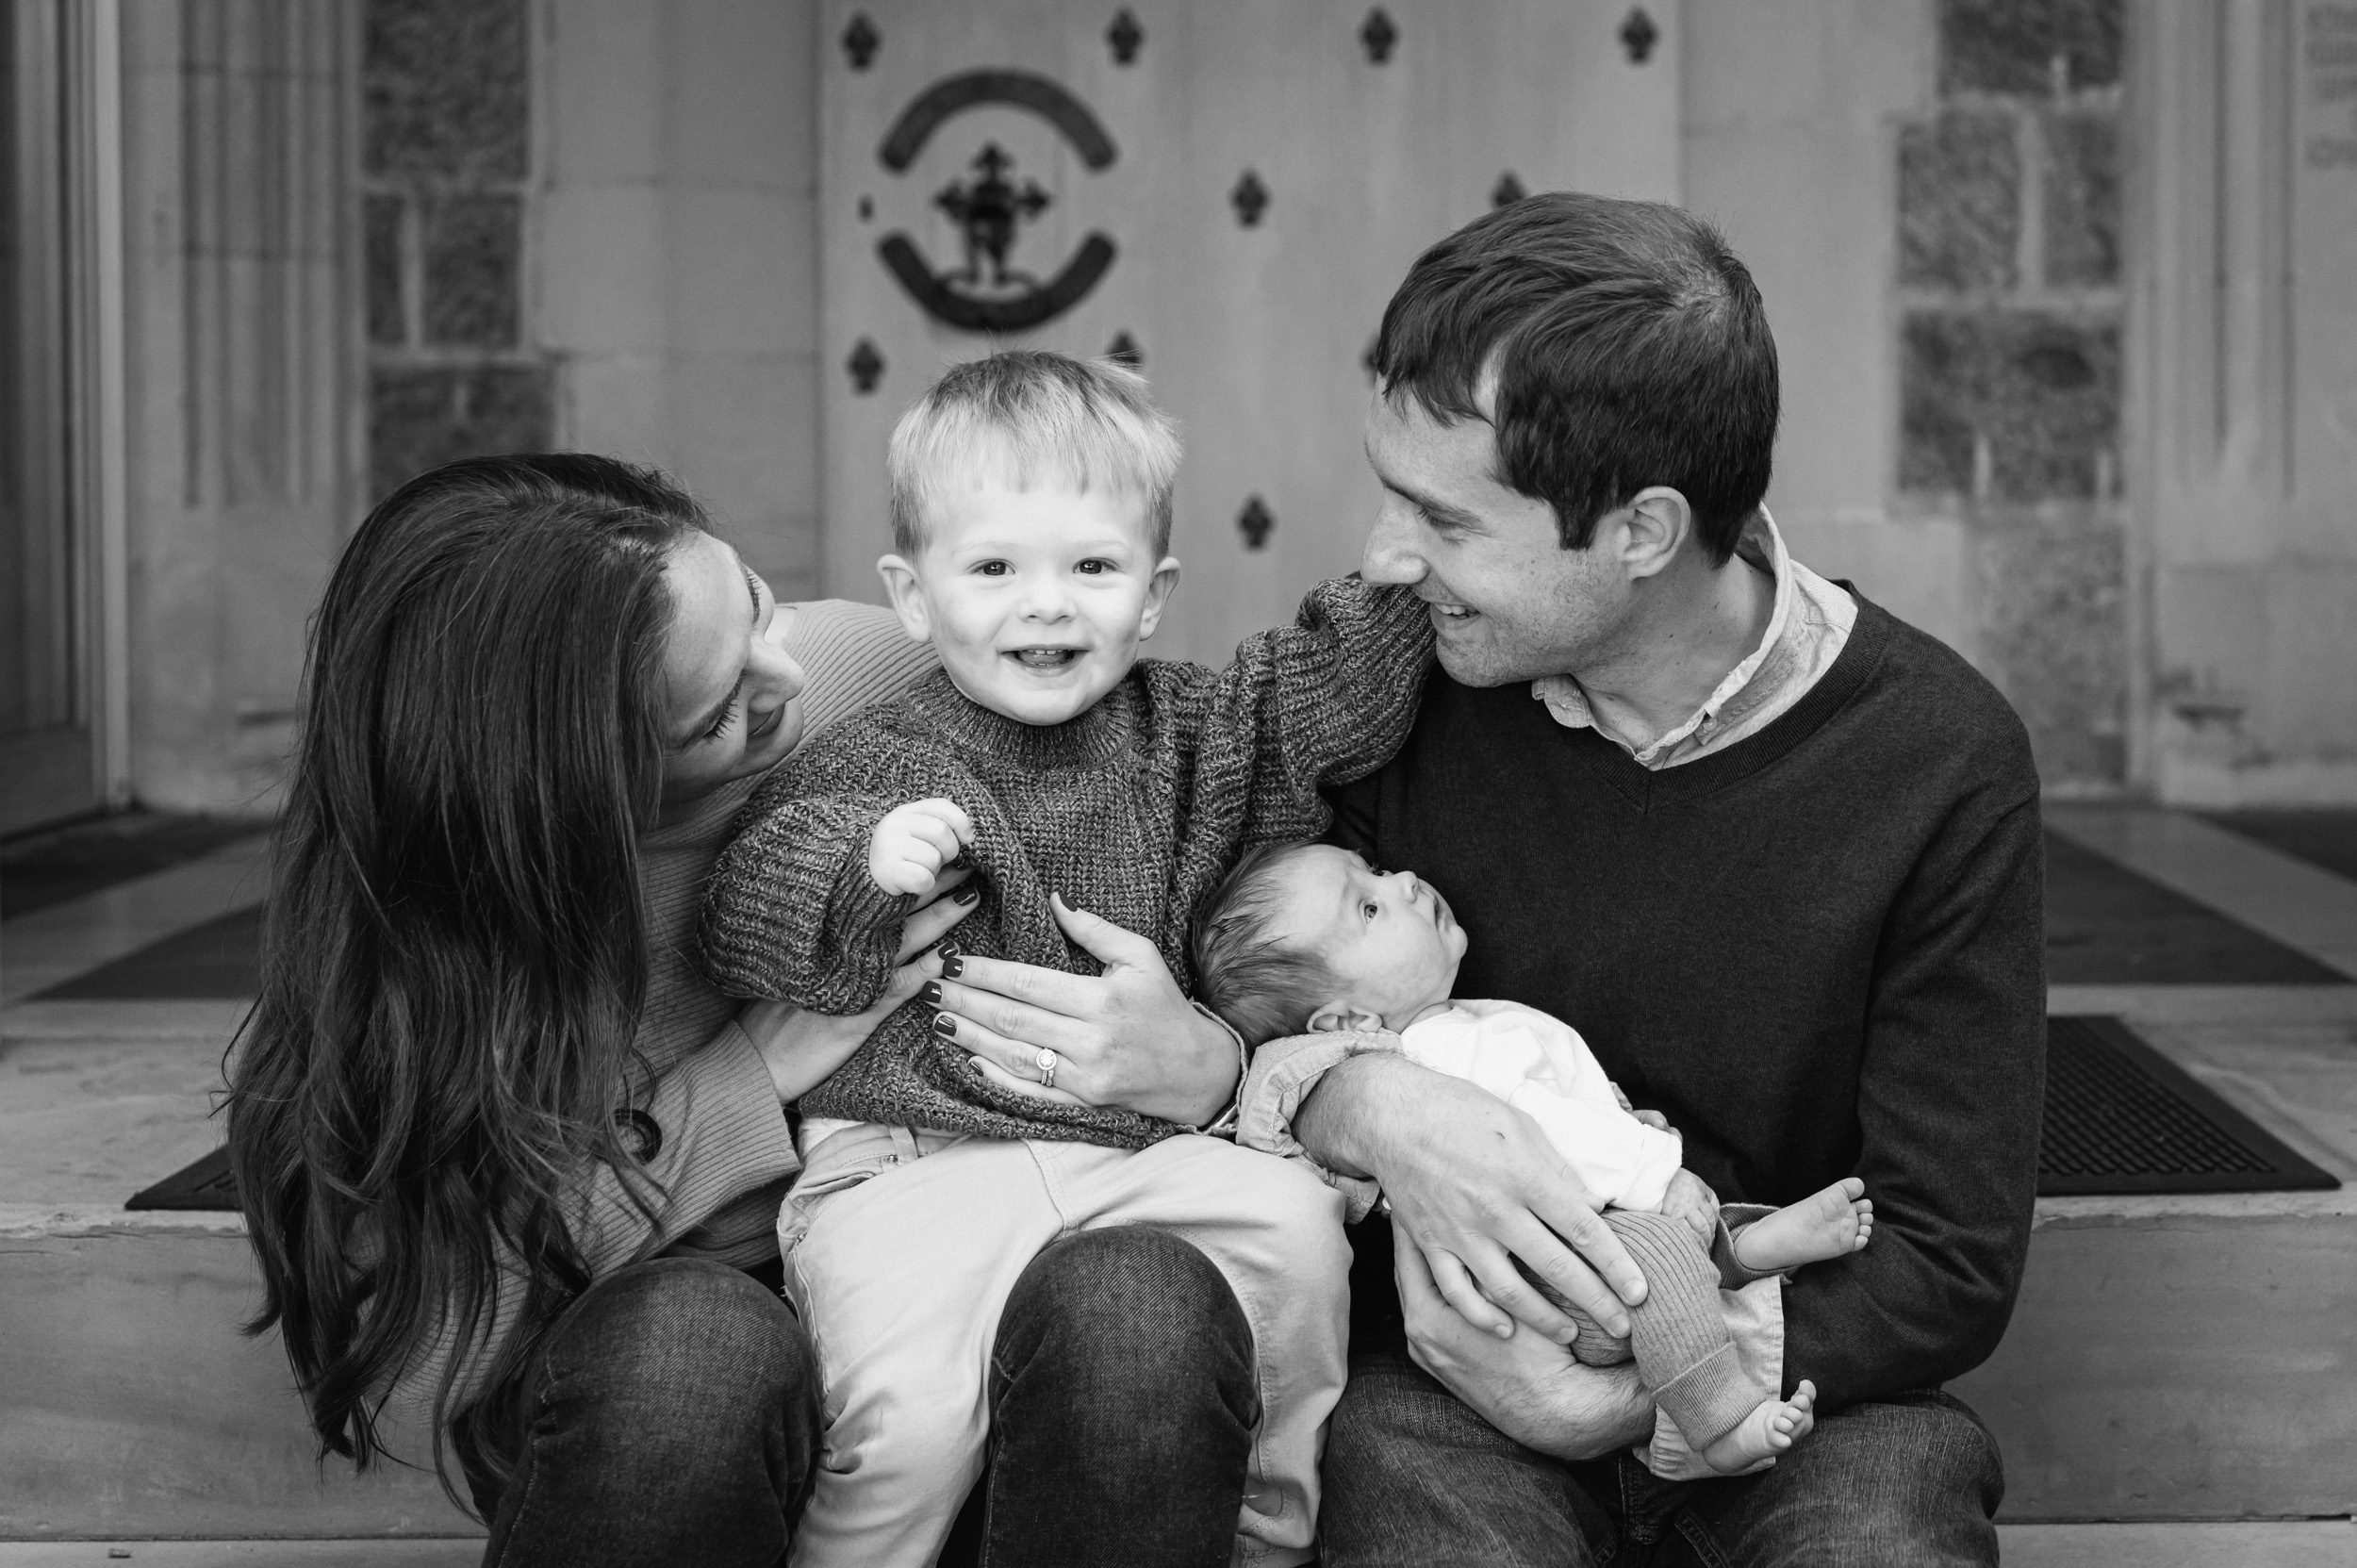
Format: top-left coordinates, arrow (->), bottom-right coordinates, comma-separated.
702,776 -> 917,1016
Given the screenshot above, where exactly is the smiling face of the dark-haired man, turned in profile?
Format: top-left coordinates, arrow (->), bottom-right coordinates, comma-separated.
1360,391 -> 1629,686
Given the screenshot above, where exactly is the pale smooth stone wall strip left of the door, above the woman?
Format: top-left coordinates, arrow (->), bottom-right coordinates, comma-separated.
528,0 -> 818,599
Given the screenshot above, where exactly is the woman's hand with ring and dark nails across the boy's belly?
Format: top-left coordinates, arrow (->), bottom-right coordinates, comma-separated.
922,899 -> 1243,1127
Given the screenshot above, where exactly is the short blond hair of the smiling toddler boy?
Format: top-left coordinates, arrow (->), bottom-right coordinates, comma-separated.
884,349 -> 1178,561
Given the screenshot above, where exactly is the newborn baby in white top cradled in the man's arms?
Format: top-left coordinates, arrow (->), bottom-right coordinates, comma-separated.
1193,844 -> 1874,1474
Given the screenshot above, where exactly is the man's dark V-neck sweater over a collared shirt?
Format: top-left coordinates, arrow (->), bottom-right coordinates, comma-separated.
1332,602 -> 2046,1410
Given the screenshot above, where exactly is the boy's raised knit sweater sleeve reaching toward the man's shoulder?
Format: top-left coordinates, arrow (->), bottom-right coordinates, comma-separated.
1202,578 -> 1433,842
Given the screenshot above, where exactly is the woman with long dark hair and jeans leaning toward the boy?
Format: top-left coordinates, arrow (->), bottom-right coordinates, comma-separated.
229,455 -> 1254,1563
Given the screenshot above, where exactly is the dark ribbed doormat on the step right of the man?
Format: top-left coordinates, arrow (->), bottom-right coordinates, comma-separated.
2039,1016 -> 2341,1197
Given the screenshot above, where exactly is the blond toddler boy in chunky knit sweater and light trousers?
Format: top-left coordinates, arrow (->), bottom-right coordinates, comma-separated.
702,352 -> 1431,1565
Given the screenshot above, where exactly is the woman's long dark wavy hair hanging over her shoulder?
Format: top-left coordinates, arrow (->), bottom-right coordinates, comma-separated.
229,455 -> 705,1497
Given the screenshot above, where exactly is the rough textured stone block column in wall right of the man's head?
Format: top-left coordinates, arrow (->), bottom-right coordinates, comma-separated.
1895,0 -> 2129,787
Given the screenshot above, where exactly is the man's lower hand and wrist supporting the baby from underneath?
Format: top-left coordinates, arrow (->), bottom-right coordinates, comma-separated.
1391,1235 -> 1653,1460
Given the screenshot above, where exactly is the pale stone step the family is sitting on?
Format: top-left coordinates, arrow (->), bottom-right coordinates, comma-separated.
0,985 -> 2357,1537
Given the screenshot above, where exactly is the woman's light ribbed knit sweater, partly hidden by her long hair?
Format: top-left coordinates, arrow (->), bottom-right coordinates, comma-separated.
394,599 -> 936,1405
